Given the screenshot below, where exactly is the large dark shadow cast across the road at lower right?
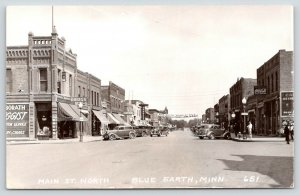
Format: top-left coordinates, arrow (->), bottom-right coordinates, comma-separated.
218,155 -> 294,188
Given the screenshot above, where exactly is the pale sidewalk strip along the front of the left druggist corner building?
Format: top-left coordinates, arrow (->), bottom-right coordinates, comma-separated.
6,135 -> 103,145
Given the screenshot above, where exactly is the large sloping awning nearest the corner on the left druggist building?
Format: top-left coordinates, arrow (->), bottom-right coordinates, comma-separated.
58,102 -> 87,121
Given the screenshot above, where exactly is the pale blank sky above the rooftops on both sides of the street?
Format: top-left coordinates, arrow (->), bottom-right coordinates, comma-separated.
6,5 -> 294,115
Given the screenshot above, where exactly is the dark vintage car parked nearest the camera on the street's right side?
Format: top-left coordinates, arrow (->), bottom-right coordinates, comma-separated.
197,124 -> 230,139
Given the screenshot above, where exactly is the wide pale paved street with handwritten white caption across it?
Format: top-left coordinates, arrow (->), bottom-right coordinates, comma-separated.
7,130 -> 294,189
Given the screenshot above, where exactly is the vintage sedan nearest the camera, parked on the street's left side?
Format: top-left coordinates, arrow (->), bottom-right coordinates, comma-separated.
103,126 -> 136,140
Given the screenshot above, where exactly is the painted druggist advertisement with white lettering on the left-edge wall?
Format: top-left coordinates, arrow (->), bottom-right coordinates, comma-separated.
6,103 -> 29,138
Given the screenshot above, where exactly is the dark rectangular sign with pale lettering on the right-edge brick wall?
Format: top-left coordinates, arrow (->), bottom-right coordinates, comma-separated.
281,92 -> 294,117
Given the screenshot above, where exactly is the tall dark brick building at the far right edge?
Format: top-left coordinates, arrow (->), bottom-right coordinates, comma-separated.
256,50 -> 294,135
